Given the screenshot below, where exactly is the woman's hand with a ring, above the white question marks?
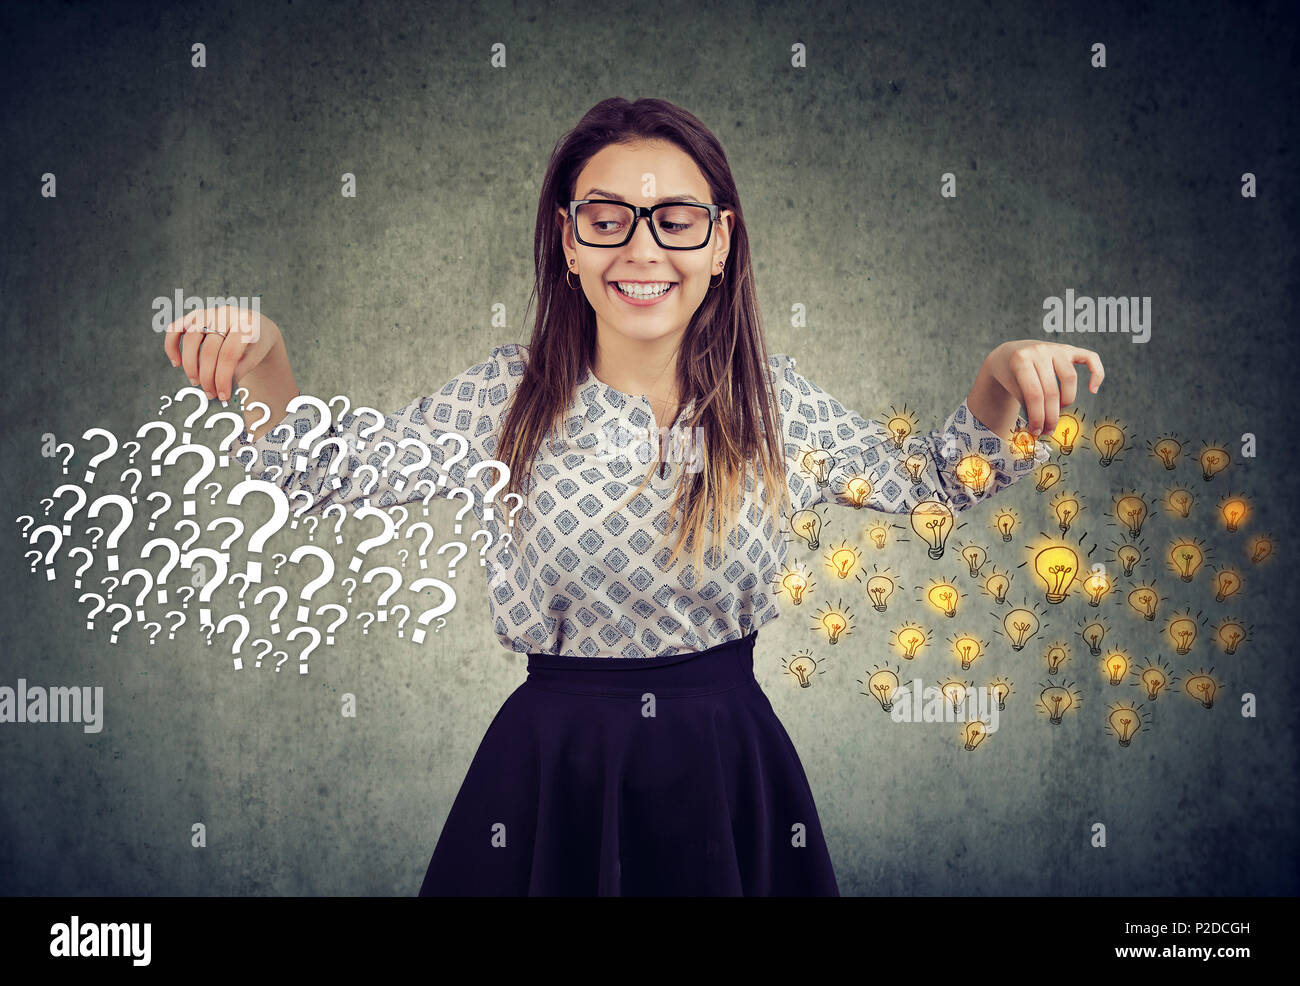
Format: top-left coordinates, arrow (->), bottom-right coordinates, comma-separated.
163,306 -> 281,401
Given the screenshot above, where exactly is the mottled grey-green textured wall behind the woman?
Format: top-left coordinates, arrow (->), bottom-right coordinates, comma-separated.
0,3 -> 1300,895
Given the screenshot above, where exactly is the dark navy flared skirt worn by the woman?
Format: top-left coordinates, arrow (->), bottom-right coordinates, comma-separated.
420,631 -> 840,896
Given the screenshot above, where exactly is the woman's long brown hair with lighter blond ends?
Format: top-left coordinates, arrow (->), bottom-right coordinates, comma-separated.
495,99 -> 789,576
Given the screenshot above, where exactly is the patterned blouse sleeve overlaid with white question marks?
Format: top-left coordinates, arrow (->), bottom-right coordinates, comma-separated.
233,343 -> 525,514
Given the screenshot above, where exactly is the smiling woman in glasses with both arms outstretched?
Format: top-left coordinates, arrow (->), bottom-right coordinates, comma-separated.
159,99 -> 1101,896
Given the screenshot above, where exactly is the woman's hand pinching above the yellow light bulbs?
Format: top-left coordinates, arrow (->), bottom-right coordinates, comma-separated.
982,340 -> 1105,437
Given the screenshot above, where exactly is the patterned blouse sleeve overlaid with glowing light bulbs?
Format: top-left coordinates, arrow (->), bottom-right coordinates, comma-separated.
770,354 -> 1050,514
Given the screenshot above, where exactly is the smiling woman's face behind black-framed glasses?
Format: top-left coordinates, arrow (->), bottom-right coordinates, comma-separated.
558,140 -> 735,342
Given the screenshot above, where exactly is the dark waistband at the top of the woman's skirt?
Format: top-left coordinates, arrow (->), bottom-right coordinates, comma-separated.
525,630 -> 758,696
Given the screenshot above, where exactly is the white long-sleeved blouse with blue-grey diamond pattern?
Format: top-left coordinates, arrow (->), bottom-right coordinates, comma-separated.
235,343 -> 1050,658
